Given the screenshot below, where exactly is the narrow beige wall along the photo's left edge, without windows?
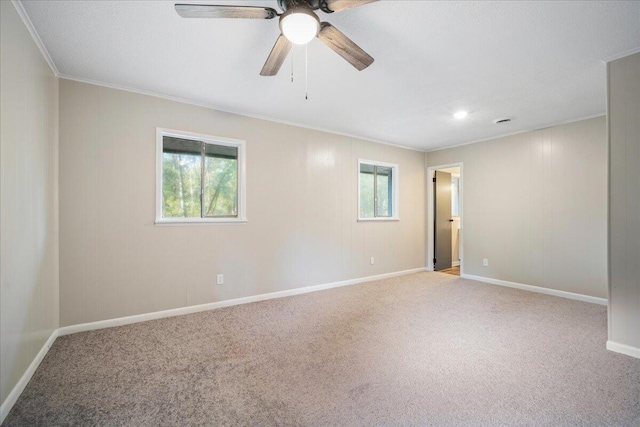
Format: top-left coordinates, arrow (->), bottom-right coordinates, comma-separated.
0,1 -> 58,403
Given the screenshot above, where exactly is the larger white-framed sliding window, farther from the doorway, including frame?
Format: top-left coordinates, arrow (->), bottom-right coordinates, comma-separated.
156,129 -> 245,224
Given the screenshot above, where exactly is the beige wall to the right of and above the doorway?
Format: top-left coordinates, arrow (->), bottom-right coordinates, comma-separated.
427,117 -> 607,298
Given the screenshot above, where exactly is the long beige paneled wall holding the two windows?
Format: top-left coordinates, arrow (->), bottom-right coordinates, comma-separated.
60,80 -> 425,326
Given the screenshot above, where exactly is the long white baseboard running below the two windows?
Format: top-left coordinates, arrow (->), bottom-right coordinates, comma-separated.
58,267 -> 425,336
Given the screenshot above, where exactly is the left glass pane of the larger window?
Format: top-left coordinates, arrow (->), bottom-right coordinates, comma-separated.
162,136 -> 202,218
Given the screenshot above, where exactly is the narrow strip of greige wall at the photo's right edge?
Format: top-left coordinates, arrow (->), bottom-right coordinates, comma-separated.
608,53 -> 640,356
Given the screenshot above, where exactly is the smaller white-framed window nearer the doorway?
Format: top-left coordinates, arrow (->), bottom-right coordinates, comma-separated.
358,160 -> 399,221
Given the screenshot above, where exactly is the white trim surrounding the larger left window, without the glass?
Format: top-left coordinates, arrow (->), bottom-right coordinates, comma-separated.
155,128 -> 247,225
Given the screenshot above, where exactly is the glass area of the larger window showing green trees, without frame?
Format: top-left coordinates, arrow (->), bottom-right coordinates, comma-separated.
162,135 -> 238,218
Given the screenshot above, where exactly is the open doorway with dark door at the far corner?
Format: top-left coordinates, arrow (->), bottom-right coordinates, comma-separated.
427,163 -> 463,276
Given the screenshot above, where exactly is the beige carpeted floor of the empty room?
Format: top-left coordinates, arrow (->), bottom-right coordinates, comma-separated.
5,273 -> 640,426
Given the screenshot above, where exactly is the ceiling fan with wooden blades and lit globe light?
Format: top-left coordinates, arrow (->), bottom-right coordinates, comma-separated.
175,0 -> 377,76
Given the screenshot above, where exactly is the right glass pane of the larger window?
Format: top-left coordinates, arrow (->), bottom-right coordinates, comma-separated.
204,144 -> 238,217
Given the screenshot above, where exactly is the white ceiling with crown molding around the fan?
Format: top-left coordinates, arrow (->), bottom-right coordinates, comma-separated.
17,0 -> 640,150
